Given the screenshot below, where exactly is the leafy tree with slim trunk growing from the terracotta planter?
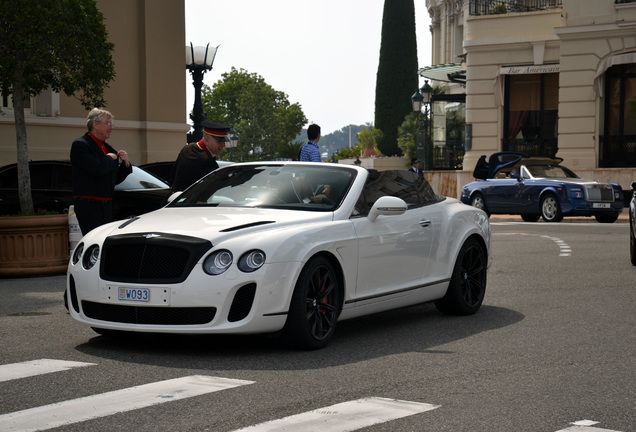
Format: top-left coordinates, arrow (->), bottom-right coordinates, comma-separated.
0,0 -> 115,214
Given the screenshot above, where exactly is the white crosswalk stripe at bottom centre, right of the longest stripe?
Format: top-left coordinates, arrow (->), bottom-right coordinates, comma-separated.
234,397 -> 439,432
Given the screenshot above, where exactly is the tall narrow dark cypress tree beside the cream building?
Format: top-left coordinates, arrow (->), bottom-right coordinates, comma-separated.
375,0 -> 418,156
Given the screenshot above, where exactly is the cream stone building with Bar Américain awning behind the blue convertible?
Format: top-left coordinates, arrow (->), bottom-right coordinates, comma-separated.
420,0 -> 636,194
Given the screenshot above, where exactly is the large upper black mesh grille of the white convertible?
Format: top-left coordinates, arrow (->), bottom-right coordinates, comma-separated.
100,233 -> 212,283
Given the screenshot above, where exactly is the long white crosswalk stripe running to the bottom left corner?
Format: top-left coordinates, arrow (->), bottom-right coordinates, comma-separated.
0,375 -> 254,432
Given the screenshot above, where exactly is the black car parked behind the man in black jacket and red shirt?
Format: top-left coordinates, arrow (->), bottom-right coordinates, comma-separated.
0,161 -> 170,220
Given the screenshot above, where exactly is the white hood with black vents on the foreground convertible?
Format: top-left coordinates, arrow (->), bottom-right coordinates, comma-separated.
95,207 -> 333,240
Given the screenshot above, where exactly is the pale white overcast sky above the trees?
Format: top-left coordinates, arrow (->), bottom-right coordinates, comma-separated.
185,0 -> 431,135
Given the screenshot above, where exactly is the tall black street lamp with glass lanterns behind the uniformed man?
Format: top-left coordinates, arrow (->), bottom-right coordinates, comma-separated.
186,43 -> 219,143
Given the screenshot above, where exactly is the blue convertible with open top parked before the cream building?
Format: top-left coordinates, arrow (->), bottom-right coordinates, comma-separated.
461,152 -> 624,223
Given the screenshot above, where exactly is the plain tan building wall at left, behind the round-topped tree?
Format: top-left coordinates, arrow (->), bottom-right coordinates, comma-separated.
0,0 -> 190,170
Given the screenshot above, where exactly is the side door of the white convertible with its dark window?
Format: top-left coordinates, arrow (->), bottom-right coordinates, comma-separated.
352,171 -> 440,301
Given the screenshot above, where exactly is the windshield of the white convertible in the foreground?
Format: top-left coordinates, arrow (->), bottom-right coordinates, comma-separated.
168,164 -> 357,211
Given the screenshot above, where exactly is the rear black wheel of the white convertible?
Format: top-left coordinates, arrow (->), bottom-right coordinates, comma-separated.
435,238 -> 488,315
